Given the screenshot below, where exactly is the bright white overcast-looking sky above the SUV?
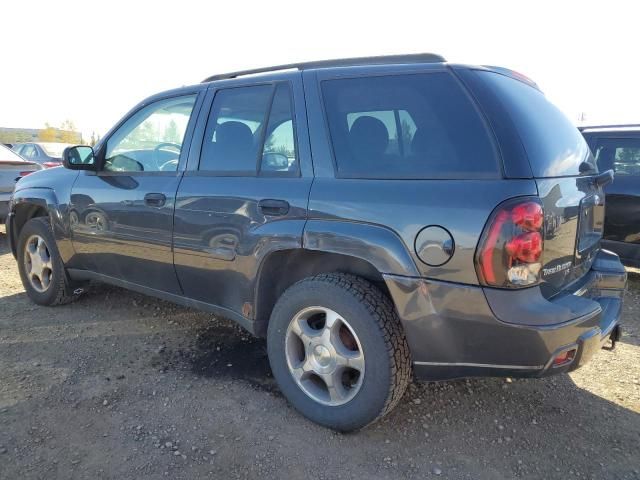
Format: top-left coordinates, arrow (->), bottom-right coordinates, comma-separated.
0,0 -> 640,139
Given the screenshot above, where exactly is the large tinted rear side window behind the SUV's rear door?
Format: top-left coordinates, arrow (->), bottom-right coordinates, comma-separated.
322,72 -> 499,179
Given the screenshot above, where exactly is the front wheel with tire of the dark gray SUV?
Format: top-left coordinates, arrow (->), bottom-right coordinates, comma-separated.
17,217 -> 73,305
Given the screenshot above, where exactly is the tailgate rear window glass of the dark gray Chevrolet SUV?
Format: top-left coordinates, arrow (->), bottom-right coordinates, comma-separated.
476,71 -> 595,177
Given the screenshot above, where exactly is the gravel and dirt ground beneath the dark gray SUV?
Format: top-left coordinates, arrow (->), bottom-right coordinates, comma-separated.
0,229 -> 640,480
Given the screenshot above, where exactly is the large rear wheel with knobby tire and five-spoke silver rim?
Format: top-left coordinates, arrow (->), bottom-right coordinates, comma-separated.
267,274 -> 411,431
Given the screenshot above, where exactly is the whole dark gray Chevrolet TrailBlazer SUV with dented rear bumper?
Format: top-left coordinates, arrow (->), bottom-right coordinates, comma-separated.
7,54 -> 626,431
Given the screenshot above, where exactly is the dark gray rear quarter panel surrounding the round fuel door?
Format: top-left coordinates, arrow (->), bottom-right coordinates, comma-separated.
305,178 -> 537,284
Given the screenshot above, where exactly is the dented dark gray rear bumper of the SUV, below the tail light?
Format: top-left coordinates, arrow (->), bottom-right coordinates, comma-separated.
385,251 -> 626,380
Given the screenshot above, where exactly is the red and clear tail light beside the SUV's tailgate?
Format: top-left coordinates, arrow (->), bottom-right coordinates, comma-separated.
476,198 -> 544,288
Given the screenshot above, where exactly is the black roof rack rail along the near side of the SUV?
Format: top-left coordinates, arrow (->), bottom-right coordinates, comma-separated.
202,53 -> 446,83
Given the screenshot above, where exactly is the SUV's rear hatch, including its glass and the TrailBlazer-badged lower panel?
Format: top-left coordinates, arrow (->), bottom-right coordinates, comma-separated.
473,70 -> 610,297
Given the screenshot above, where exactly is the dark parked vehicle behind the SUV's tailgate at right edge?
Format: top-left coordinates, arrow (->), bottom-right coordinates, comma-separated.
580,125 -> 640,267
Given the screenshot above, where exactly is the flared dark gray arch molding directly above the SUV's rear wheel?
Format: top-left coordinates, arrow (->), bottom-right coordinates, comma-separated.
302,220 -> 420,277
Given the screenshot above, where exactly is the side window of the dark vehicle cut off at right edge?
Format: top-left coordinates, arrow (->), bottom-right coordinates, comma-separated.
594,138 -> 640,177
